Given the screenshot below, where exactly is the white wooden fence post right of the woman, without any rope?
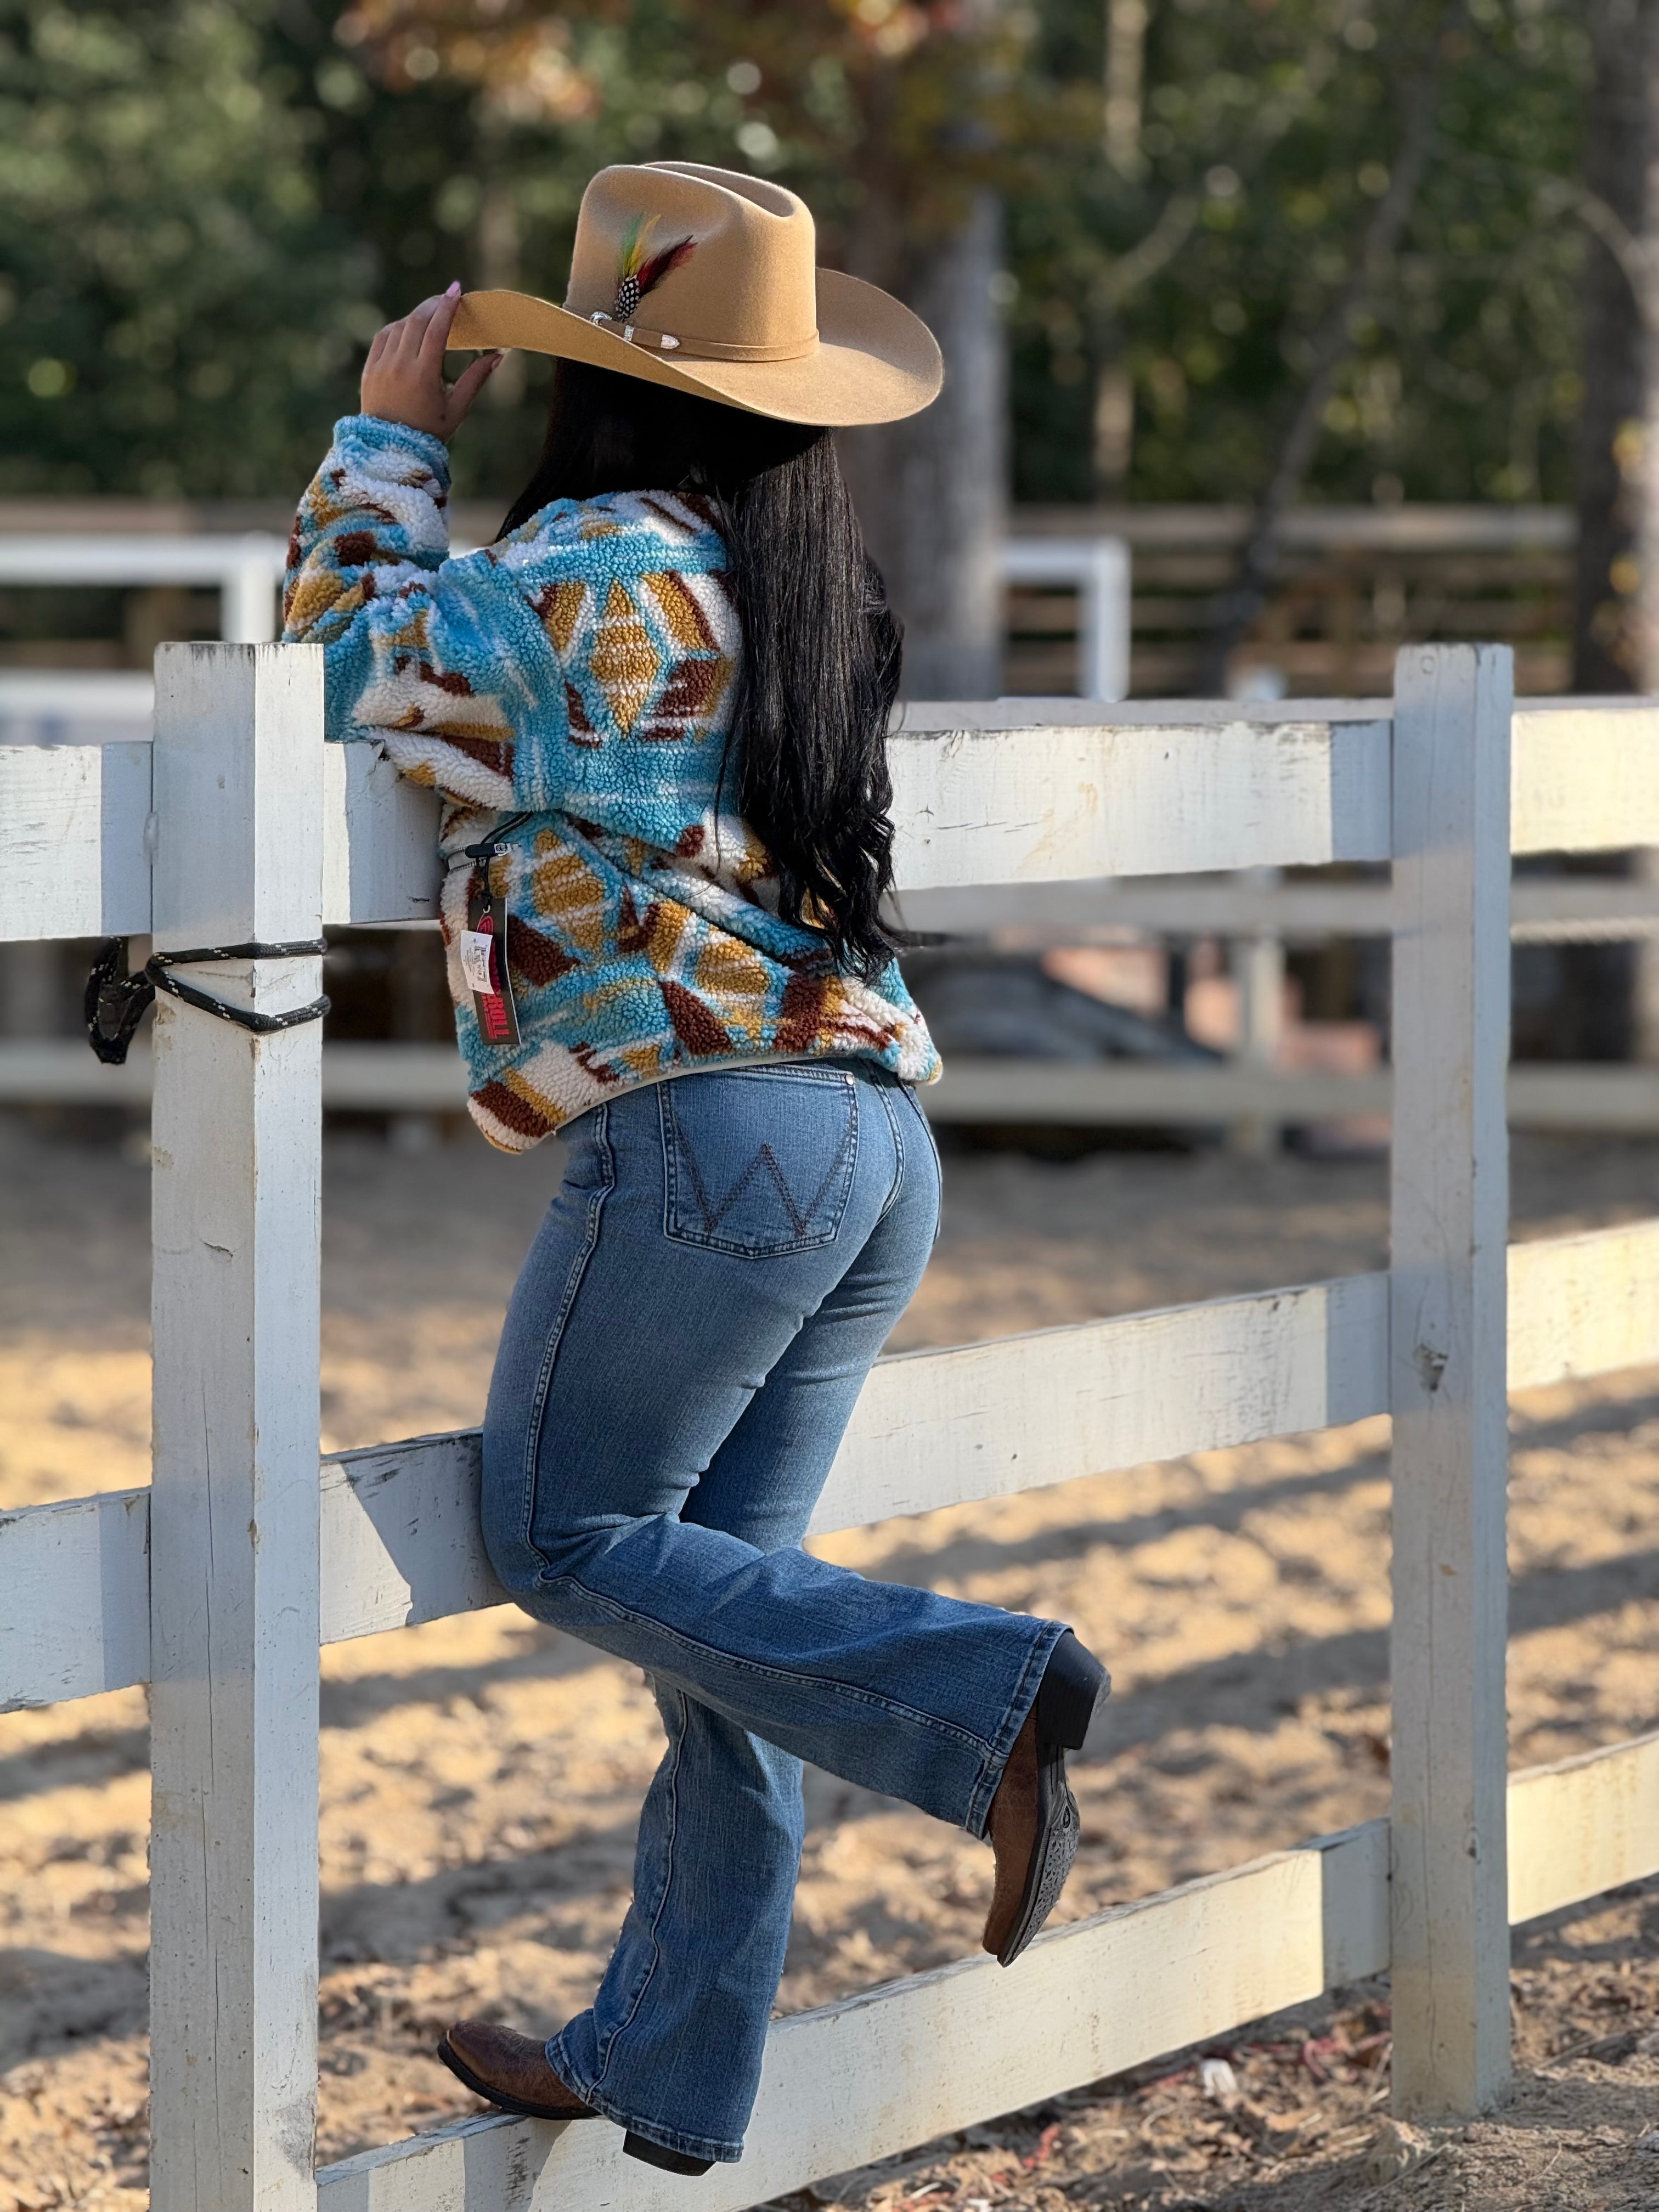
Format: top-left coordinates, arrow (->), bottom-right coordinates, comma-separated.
1389,646 -> 1513,2117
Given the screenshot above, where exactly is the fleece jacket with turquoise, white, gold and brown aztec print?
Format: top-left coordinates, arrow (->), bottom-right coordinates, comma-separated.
283,416 -> 938,1153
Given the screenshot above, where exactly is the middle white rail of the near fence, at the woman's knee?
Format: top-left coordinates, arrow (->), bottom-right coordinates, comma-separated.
0,1221 -> 1659,1710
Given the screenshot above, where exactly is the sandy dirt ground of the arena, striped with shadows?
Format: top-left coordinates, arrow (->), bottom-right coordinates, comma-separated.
0,1121 -> 1659,2212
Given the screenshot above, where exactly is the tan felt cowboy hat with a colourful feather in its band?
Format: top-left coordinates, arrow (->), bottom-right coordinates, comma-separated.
449,161 -> 945,427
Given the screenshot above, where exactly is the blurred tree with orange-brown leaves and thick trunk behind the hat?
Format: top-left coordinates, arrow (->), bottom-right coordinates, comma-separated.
336,0 -> 1092,697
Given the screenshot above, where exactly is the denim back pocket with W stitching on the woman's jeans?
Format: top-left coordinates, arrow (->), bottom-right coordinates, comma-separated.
657,1068 -> 858,1259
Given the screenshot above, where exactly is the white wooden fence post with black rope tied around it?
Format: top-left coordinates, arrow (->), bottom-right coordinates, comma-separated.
150,644 -> 323,2212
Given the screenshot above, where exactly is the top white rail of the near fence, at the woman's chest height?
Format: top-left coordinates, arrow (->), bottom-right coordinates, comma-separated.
13,695 -> 1659,940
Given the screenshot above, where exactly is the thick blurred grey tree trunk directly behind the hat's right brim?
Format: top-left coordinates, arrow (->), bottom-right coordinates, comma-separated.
840,193 -> 1009,699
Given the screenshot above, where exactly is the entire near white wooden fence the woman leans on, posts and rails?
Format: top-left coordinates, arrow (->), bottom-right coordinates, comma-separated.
0,646 -> 1659,2212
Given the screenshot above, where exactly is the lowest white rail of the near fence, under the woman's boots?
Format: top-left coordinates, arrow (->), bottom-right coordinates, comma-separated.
317,1736 -> 1659,2212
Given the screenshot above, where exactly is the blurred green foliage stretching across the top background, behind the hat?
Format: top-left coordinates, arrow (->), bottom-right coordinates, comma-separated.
0,0 -> 1588,500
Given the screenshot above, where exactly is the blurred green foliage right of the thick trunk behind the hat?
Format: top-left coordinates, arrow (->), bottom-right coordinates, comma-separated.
1011,0 -> 1590,500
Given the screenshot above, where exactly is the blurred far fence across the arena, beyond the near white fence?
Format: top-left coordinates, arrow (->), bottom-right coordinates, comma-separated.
0,513 -> 1659,1148
